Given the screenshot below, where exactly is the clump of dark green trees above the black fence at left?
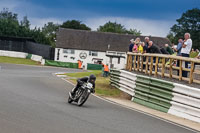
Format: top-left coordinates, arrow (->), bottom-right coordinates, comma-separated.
0,8 -> 52,45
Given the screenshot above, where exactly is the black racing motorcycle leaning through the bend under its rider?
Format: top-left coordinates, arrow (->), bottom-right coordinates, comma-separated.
68,82 -> 93,106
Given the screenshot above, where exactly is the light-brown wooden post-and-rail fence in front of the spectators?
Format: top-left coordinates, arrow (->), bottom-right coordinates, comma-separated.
126,52 -> 200,84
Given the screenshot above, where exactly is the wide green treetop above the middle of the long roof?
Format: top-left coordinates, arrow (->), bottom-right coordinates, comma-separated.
97,21 -> 141,36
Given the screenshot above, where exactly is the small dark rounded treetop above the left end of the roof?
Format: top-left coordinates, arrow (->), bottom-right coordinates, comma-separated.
60,20 -> 91,30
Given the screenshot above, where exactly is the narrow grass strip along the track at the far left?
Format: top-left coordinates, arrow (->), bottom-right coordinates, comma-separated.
0,56 -> 39,65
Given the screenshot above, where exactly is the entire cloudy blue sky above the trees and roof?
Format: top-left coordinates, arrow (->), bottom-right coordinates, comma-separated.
0,0 -> 200,37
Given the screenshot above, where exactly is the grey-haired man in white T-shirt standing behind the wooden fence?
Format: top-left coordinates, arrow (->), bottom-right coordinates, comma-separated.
181,33 -> 192,77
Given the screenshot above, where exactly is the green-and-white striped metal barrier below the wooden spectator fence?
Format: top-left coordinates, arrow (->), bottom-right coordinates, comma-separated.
110,70 -> 200,122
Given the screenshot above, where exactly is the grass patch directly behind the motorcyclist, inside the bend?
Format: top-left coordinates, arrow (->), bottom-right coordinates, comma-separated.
66,70 -> 121,97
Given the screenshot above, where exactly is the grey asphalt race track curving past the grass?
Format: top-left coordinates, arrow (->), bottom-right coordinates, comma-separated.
0,63 -> 197,133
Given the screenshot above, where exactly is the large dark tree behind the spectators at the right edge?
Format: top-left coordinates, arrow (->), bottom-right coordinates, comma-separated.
167,8 -> 200,49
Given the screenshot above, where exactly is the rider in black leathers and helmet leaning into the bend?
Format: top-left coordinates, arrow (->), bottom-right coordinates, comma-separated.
70,74 -> 96,96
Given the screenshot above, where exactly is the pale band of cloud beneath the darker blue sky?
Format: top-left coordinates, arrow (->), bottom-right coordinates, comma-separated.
0,0 -> 175,37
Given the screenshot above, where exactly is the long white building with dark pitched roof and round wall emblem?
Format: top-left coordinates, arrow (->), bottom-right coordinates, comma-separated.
55,28 -> 168,69
